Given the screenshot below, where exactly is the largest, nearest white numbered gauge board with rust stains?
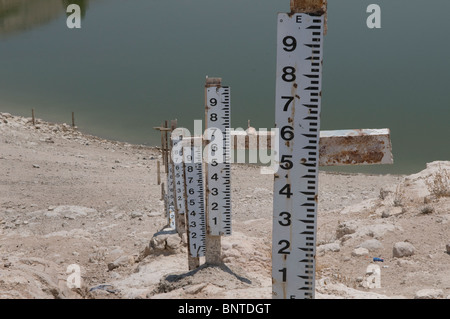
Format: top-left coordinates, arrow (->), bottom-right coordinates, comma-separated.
272,13 -> 324,299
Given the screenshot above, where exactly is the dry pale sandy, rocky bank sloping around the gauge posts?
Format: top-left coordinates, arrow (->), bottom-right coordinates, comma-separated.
0,113 -> 450,299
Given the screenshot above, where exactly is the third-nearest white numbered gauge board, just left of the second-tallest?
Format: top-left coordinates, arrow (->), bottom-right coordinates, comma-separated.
184,146 -> 206,257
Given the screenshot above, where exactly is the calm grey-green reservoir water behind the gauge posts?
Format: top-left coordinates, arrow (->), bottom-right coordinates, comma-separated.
0,0 -> 450,174
